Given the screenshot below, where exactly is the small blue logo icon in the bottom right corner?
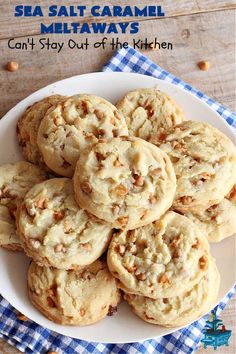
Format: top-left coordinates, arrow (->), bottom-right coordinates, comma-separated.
201,310 -> 232,350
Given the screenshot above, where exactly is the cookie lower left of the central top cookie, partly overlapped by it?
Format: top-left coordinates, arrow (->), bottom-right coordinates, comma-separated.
17,178 -> 112,269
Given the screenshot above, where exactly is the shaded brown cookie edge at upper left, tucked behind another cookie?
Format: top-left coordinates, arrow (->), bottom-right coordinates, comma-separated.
17,95 -> 64,167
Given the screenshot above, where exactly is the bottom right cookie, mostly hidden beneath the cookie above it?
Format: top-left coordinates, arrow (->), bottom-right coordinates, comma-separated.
124,259 -> 220,327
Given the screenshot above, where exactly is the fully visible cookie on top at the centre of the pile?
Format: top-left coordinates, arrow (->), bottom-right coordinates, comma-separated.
73,137 -> 176,229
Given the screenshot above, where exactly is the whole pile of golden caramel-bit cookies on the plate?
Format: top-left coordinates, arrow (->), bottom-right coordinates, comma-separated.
0,89 -> 236,327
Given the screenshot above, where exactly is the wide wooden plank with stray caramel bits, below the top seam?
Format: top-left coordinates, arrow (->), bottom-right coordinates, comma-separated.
0,10 -> 235,116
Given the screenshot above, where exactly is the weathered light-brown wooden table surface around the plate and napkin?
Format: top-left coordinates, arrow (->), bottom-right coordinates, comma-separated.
0,0 -> 236,354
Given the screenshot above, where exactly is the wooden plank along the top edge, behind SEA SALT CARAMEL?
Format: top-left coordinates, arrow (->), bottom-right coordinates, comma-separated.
0,0 -> 236,39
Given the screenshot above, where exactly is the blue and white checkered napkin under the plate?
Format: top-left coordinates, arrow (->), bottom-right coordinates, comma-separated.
0,48 -> 236,354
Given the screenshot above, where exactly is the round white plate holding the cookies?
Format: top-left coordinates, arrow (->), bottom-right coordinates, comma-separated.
0,73 -> 235,343
